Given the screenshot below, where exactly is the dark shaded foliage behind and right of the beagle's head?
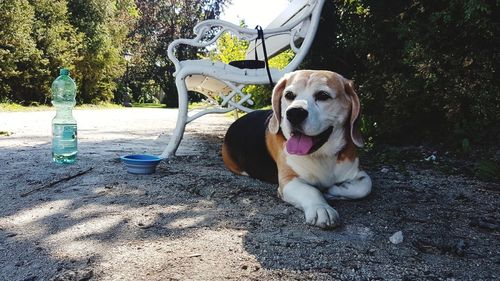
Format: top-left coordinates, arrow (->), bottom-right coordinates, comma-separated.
304,0 -> 500,146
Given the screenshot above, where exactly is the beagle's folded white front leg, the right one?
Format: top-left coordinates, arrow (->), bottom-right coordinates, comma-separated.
325,171 -> 372,199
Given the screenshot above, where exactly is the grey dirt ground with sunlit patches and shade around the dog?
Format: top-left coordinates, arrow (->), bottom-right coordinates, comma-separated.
0,108 -> 500,281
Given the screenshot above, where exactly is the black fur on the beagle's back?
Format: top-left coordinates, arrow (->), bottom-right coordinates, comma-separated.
224,110 -> 278,183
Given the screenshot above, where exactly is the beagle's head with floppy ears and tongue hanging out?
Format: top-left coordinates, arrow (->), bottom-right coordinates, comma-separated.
269,70 -> 363,155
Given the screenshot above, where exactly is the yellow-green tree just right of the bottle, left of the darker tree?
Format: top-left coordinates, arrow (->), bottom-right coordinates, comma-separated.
68,0 -> 138,103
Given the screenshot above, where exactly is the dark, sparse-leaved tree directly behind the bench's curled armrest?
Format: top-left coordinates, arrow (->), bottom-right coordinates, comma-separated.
131,0 -> 229,107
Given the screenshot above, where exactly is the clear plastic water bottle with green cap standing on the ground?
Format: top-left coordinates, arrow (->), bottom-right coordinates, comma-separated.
51,68 -> 78,163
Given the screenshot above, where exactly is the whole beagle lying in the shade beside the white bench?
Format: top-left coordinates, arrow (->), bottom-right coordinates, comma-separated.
222,70 -> 372,228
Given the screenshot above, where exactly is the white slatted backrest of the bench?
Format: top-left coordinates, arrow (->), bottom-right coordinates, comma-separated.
246,0 -> 324,63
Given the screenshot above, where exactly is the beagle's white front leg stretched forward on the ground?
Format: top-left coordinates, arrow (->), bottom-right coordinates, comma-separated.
283,179 -> 339,228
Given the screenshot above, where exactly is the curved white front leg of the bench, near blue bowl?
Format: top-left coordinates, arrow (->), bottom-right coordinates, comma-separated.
160,76 -> 188,158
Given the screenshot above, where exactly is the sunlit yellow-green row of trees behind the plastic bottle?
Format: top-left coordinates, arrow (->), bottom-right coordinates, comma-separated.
0,0 -> 137,104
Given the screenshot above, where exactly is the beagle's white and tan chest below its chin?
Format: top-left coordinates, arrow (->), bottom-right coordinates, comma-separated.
287,155 -> 359,189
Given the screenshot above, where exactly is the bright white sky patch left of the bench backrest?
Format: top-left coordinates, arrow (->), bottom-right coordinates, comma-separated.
220,0 -> 289,28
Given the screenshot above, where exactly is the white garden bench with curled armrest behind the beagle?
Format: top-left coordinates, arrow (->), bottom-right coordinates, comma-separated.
161,0 -> 324,158
